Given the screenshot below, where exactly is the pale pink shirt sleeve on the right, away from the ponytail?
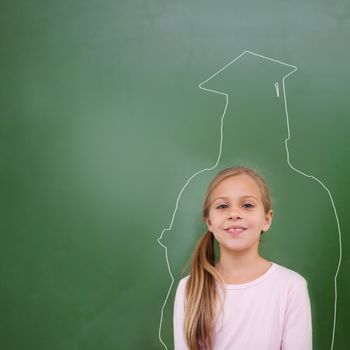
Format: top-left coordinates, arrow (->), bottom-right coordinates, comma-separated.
281,278 -> 312,350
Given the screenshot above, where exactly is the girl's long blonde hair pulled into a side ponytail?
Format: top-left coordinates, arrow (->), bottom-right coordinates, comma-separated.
184,166 -> 271,350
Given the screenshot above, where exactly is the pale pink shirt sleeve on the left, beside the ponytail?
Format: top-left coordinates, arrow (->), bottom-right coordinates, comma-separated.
173,279 -> 188,350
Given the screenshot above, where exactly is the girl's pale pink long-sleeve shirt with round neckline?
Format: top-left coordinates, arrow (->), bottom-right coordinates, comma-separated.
174,262 -> 312,350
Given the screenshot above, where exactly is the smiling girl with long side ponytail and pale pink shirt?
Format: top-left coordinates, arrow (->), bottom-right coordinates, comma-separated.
174,167 -> 312,350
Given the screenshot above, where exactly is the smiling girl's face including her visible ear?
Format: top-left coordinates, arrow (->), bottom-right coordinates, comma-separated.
206,174 -> 272,254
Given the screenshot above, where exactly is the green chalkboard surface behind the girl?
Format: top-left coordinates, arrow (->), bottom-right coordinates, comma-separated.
0,0 -> 350,350
